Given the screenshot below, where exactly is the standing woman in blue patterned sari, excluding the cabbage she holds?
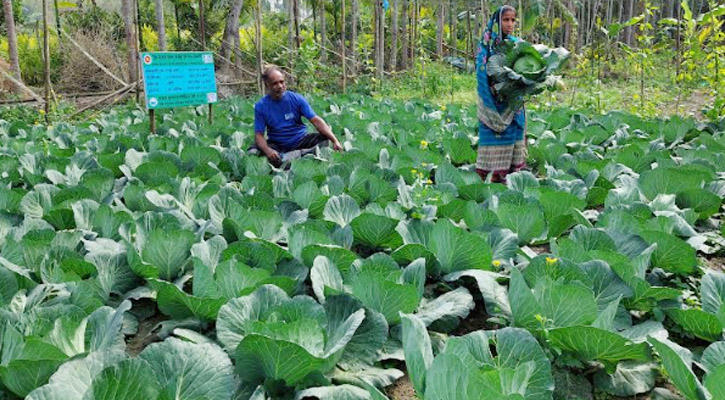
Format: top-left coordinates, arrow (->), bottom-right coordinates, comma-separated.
476,6 -> 526,183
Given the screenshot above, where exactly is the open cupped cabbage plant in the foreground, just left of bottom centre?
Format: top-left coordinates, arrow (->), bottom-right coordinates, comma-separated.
217,285 -> 364,386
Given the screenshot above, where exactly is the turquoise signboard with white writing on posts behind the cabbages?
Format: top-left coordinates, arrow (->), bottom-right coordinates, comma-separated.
140,51 -> 217,110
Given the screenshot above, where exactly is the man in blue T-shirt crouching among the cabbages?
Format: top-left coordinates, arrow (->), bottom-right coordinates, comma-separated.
252,67 -> 342,167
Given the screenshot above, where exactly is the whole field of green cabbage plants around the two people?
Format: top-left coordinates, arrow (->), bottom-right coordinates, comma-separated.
0,96 -> 725,400
